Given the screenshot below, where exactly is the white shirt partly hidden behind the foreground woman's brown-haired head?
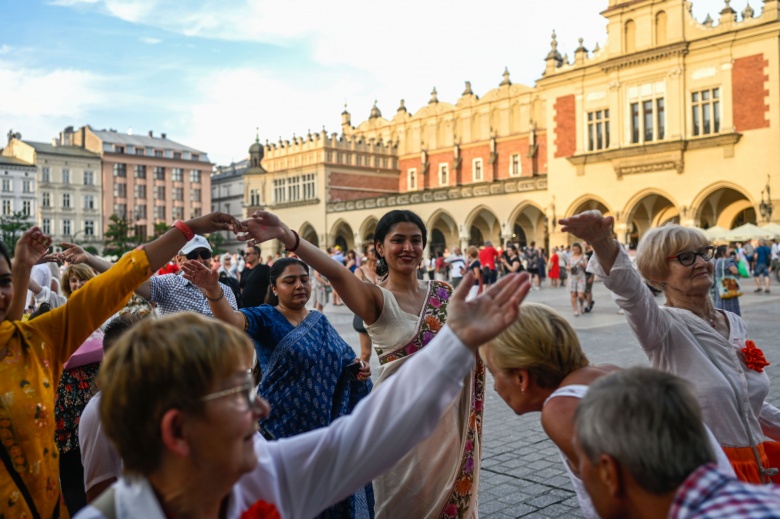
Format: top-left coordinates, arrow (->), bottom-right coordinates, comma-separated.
79,391 -> 122,490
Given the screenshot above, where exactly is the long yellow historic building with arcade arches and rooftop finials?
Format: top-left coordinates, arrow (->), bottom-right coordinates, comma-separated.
245,0 -> 780,252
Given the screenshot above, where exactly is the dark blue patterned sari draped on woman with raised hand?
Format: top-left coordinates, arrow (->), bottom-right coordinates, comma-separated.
257,311 -> 374,519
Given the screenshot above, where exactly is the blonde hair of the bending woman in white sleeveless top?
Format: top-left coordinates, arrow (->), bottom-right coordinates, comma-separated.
480,303 -> 588,388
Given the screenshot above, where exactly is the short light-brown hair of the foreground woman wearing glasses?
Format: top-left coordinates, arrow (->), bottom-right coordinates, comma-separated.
98,312 -> 254,476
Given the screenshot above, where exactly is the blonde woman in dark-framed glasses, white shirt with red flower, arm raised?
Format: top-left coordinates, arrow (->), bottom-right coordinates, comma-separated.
560,211 -> 780,483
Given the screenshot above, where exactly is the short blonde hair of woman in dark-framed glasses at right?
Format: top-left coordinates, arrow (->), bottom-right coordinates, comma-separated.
636,224 -> 708,288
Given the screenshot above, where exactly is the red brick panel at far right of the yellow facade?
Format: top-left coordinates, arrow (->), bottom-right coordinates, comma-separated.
731,54 -> 769,132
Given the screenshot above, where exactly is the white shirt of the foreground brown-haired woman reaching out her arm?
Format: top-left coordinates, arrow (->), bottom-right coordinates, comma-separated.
76,326 -> 474,519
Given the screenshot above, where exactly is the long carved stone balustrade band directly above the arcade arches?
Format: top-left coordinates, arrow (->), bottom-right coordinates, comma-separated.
326,175 -> 547,213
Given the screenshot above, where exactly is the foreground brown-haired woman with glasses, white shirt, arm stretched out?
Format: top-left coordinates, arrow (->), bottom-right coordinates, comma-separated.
78,275 -> 530,519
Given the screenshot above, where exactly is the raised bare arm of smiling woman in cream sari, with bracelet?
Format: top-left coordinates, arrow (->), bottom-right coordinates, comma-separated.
239,211 -> 382,324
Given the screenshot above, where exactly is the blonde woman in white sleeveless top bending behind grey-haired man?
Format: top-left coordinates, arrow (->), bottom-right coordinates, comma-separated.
480,303 -> 734,519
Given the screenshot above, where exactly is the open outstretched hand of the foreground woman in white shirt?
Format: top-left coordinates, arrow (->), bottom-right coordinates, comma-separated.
447,271 -> 531,351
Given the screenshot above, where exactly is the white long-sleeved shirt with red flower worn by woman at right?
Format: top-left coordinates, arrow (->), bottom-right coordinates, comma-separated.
588,247 -> 780,447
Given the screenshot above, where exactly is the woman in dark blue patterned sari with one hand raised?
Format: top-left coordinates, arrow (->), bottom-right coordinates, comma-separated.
183,258 -> 374,519
